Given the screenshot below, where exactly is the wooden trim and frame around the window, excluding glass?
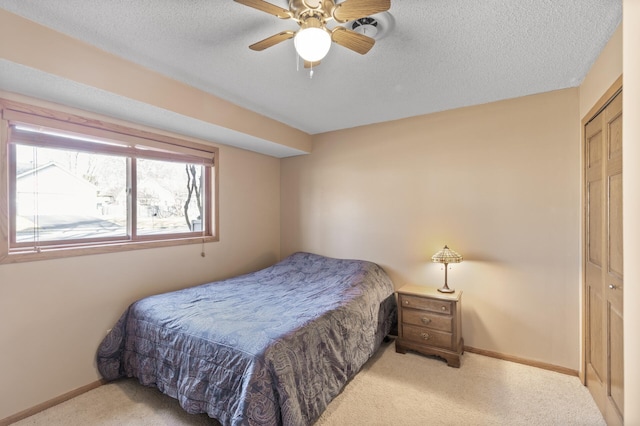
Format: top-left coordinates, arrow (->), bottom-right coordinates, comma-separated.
0,98 -> 219,264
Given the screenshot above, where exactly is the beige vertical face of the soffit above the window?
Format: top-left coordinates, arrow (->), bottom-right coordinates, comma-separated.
0,9 -> 311,152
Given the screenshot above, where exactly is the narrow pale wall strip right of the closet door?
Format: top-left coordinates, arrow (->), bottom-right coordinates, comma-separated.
622,0 -> 640,425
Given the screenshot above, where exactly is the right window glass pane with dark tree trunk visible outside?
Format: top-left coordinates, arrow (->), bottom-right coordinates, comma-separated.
137,159 -> 204,235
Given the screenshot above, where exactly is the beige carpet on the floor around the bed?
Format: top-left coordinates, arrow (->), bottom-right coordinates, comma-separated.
15,342 -> 605,426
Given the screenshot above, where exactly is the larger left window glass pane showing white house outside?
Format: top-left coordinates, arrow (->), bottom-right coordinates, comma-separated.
15,144 -> 127,245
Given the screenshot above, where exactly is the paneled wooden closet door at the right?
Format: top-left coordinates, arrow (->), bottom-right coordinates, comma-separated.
584,91 -> 624,425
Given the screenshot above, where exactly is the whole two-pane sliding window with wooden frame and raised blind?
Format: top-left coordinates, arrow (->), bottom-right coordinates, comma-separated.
0,100 -> 217,262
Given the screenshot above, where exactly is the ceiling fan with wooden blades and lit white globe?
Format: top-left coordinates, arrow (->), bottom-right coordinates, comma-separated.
235,0 -> 391,68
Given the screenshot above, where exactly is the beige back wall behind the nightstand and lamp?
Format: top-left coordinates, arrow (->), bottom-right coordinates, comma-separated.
281,89 -> 580,370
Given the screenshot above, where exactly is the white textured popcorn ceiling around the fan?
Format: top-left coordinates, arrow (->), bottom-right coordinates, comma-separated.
0,0 -> 622,141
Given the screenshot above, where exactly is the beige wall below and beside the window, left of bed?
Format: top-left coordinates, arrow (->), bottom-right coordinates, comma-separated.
0,95 -> 280,419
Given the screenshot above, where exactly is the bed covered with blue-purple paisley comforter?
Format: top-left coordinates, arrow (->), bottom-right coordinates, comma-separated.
97,252 -> 396,426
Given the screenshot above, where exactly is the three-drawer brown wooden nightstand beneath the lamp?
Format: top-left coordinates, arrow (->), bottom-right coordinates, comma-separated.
396,284 -> 464,367
